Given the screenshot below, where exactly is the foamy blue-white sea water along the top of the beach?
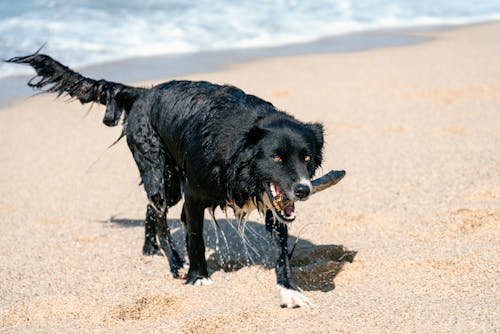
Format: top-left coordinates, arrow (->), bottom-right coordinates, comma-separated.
0,0 -> 500,78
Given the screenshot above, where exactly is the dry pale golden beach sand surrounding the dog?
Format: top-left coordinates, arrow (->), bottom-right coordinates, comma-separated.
0,23 -> 500,333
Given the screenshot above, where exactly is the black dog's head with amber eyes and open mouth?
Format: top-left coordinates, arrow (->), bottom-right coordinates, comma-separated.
247,115 -> 323,223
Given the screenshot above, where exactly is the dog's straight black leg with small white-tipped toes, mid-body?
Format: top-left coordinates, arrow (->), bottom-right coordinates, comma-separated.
182,197 -> 212,285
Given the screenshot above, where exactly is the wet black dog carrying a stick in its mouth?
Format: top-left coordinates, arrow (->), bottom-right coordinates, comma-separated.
8,53 -> 344,307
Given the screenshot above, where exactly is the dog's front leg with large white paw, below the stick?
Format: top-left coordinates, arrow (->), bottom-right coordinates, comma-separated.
266,210 -> 313,308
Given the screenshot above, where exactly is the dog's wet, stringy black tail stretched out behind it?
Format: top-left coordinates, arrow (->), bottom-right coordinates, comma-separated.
7,52 -> 142,126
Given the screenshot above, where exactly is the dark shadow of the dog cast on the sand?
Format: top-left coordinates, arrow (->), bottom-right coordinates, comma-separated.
106,218 -> 356,292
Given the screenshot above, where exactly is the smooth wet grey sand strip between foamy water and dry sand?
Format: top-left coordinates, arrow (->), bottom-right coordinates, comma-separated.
0,21 -> 450,109
